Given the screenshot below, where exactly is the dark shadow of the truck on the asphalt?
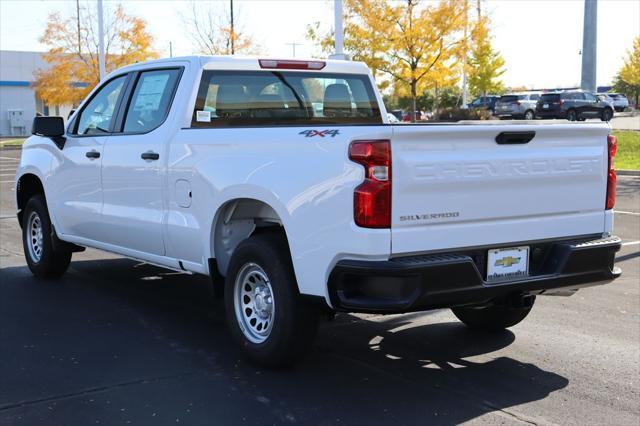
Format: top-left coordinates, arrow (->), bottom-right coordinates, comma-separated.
0,259 -> 568,425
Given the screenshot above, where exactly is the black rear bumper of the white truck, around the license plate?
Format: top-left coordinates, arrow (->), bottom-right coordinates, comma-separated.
329,237 -> 621,313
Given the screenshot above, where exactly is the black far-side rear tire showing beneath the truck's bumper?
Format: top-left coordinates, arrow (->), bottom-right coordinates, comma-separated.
451,296 -> 536,331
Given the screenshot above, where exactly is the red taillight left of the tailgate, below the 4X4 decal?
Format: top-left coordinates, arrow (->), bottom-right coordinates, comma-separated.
349,140 -> 391,228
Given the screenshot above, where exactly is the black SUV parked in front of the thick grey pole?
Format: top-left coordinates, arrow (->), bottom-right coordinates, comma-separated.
536,91 -> 613,121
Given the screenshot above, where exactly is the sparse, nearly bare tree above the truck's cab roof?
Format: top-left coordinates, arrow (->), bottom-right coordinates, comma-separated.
182,1 -> 260,55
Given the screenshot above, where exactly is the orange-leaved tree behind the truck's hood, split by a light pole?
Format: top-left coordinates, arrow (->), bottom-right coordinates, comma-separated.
35,5 -> 158,105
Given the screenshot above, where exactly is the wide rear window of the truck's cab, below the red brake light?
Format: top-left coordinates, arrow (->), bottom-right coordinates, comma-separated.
191,71 -> 382,128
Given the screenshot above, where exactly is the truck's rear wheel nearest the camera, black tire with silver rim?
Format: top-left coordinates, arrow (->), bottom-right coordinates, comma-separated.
224,232 -> 319,367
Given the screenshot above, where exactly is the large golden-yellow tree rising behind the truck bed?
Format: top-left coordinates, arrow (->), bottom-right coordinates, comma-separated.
308,0 -> 468,120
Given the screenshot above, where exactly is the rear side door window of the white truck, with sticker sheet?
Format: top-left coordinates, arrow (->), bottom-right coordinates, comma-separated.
123,68 -> 181,133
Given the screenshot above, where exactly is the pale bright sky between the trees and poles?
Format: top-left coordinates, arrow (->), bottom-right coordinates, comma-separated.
0,0 -> 640,87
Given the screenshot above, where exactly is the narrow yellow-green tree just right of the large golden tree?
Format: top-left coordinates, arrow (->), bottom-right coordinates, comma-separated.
467,17 -> 506,96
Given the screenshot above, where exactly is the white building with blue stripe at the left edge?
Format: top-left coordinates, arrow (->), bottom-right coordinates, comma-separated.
0,50 -> 71,137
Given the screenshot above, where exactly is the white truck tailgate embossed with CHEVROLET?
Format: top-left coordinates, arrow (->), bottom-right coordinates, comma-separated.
391,123 -> 609,254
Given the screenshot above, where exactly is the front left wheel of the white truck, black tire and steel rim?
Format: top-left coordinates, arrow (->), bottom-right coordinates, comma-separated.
22,194 -> 71,279
